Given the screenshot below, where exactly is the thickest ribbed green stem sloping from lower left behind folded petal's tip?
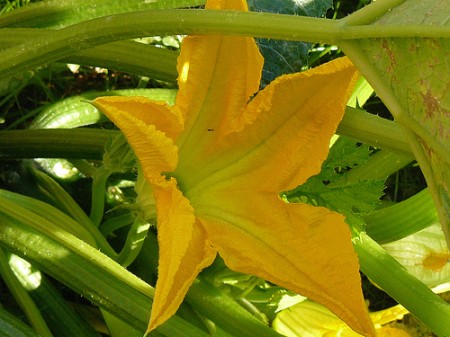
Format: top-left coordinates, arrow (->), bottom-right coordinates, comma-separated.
0,212 -> 213,337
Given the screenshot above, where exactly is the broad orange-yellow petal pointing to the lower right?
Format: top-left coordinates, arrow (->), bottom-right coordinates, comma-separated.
194,187 -> 375,336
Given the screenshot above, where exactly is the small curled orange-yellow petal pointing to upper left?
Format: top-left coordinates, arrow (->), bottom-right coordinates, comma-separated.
93,97 -> 178,185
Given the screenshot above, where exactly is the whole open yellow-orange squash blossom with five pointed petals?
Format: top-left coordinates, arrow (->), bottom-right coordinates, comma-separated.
94,0 -> 374,336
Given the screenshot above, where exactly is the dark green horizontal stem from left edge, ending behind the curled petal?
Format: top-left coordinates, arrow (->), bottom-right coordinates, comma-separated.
0,129 -> 118,160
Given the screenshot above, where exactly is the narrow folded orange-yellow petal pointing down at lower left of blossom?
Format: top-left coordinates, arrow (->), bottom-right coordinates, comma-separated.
147,179 -> 216,332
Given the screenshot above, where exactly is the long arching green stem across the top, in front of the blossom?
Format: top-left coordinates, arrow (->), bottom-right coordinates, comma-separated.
0,10 -> 450,78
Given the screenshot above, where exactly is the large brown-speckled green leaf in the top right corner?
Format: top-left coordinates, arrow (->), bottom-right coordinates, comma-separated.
339,0 -> 450,245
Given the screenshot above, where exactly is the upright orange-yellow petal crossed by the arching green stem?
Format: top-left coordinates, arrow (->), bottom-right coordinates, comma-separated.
175,0 -> 263,171
